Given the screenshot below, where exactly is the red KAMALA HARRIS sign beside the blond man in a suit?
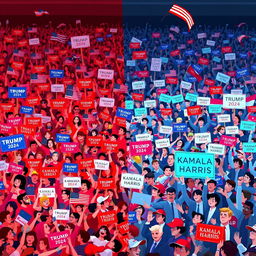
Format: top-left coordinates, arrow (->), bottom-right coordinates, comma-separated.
195,223 -> 225,244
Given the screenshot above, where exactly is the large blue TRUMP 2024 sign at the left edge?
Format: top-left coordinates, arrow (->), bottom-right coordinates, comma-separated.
0,134 -> 26,152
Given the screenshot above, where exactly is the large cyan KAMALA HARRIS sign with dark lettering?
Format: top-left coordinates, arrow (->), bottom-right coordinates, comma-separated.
174,151 -> 215,179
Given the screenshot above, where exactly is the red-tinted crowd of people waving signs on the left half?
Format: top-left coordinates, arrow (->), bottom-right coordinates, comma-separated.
0,20 -> 129,256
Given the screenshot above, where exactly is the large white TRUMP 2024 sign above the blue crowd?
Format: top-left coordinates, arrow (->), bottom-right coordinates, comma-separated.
223,94 -> 246,109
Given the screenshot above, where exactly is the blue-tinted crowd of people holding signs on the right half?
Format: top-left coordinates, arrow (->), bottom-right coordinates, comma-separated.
124,24 -> 256,256
